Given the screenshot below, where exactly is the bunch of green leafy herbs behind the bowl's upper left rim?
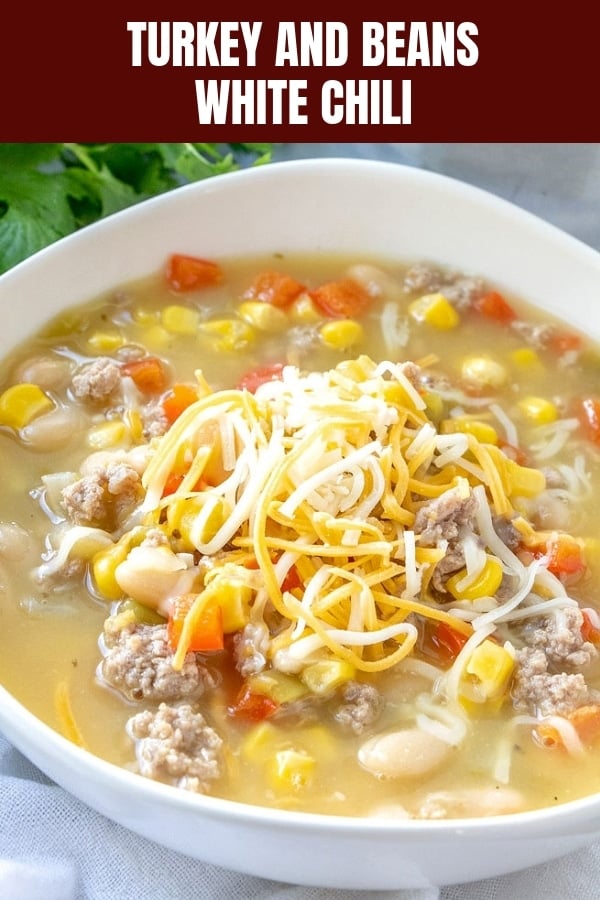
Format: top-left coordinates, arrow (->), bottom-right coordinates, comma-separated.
0,143 -> 273,274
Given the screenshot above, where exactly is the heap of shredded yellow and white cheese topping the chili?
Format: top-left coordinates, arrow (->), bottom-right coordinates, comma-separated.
122,356 -> 556,680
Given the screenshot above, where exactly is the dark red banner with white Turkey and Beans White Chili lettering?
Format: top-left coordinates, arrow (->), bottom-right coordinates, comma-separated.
0,2 -> 600,142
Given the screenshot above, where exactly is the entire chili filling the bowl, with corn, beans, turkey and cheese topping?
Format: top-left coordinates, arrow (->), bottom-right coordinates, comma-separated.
0,248 -> 600,818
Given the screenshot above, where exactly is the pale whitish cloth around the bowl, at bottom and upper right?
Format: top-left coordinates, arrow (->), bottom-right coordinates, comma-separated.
0,143 -> 600,900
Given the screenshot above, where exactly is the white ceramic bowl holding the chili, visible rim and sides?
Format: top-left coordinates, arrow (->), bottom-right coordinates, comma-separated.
0,159 -> 600,890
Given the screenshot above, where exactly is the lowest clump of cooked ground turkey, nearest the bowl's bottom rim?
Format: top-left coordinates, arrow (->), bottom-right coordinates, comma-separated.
127,703 -> 223,794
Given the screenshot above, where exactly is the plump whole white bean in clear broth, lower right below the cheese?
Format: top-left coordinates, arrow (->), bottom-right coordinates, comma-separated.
358,728 -> 452,778
